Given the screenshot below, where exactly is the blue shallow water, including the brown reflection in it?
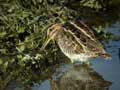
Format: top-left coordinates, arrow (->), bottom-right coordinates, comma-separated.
32,22 -> 120,90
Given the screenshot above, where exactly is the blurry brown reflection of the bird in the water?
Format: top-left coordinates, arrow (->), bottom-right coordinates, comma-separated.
50,65 -> 111,90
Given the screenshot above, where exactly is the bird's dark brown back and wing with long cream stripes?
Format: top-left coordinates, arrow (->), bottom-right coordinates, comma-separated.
63,21 -> 103,51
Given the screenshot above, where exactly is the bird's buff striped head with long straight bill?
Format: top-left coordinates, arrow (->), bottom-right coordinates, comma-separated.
41,24 -> 62,50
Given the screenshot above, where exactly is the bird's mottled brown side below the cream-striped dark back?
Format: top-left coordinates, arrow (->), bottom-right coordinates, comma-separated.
57,28 -> 84,54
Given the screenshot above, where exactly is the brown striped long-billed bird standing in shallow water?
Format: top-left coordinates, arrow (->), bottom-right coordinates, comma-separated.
41,20 -> 111,63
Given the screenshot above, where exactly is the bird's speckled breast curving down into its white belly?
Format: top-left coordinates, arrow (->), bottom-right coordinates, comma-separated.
56,34 -> 90,62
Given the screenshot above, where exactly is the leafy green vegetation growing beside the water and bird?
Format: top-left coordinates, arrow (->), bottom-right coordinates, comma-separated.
0,0 -> 118,90
